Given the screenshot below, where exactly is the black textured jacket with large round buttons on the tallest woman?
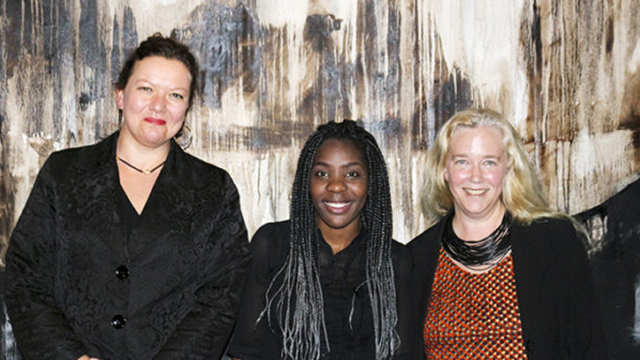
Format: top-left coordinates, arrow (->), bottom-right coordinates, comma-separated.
6,133 -> 249,359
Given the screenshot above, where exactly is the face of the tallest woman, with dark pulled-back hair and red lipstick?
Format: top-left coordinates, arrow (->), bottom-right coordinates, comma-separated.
116,56 -> 191,148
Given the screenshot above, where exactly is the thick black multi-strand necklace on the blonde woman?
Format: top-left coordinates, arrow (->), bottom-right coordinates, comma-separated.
442,212 -> 511,270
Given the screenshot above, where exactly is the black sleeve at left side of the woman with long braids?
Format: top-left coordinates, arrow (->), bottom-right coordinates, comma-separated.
228,223 -> 289,360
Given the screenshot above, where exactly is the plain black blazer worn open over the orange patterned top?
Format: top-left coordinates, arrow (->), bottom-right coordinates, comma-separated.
408,218 -> 607,360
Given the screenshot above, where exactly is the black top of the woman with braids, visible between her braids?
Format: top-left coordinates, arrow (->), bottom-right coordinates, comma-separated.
229,221 -> 418,360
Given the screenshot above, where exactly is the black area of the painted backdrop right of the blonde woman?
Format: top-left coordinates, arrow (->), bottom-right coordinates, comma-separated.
575,179 -> 640,360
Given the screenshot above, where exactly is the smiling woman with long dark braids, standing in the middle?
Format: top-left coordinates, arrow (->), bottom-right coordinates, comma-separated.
229,120 -> 410,360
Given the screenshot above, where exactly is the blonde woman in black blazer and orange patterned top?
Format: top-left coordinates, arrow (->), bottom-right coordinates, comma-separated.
409,109 -> 607,360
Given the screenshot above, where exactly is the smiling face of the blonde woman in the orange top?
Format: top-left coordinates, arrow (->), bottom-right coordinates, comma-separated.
444,127 -> 508,221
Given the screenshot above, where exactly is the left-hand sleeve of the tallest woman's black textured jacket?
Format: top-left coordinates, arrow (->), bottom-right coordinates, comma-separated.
5,154 -> 86,359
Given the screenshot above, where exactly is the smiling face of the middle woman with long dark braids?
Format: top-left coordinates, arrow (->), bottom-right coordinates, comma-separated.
311,139 -> 368,237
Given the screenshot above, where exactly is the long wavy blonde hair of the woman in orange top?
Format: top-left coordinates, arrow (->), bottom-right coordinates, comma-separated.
421,109 -> 568,224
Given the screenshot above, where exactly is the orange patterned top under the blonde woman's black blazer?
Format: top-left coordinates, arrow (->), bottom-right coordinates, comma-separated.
424,249 -> 527,360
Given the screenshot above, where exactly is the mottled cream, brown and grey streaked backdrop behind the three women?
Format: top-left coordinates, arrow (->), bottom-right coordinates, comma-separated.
0,0 -> 640,358
